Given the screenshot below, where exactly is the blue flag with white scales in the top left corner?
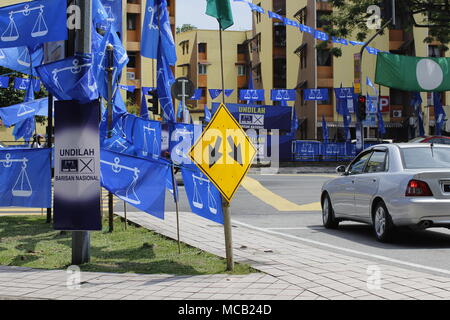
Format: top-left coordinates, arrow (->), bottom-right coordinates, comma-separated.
0,0 -> 68,48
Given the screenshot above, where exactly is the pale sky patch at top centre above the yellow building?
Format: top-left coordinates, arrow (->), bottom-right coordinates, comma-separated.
175,0 -> 252,31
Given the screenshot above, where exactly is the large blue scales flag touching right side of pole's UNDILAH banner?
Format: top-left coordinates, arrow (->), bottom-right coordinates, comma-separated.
100,150 -> 170,219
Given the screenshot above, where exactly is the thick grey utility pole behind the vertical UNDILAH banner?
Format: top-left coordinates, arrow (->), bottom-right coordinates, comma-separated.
72,0 -> 92,265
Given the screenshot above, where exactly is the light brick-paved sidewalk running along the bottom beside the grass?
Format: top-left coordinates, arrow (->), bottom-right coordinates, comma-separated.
0,212 -> 450,300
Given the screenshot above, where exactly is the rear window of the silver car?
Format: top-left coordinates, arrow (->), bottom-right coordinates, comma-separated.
401,145 -> 450,169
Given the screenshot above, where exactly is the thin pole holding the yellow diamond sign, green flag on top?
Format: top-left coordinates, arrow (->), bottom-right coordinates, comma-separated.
219,23 -> 234,271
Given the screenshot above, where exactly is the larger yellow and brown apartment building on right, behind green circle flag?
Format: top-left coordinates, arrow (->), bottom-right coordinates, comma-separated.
250,0 -> 450,140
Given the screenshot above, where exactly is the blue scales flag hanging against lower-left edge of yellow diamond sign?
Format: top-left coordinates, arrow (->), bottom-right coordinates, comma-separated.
181,164 -> 223,224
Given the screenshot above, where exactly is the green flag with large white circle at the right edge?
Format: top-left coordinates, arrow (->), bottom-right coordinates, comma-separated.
375,52 -> 450,92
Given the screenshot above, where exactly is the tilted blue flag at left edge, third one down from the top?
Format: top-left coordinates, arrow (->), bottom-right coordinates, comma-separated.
0,98 -> 48,127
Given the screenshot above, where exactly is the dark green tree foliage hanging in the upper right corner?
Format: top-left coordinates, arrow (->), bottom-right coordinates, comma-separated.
319,0 -> 450,56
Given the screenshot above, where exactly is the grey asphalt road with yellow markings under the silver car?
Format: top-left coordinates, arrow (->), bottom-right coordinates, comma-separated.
120,174 -> 450,276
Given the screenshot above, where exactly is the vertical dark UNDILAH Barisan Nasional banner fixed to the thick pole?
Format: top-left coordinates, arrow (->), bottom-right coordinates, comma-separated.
54,100 -> 102,231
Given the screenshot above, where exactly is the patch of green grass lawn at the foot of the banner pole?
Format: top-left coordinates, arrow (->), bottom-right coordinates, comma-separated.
0,216 -> 256,275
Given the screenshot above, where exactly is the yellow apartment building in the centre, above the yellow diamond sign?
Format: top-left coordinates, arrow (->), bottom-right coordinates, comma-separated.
176,29 -> 252,121
